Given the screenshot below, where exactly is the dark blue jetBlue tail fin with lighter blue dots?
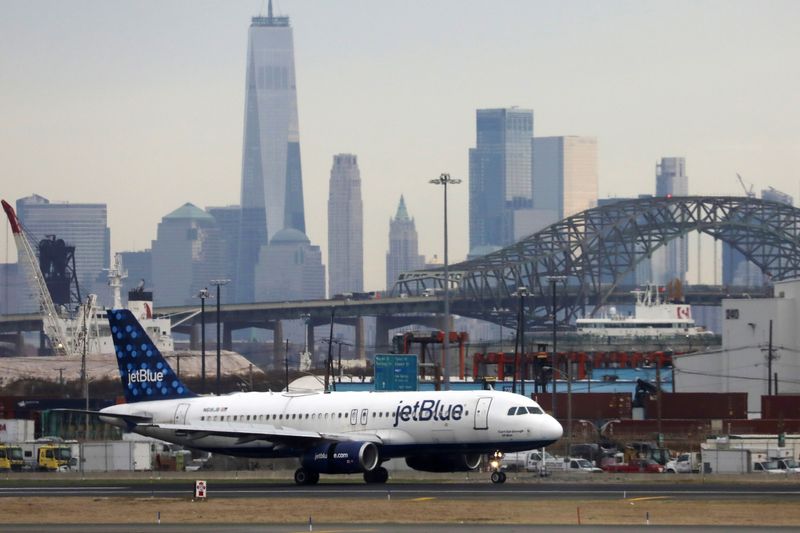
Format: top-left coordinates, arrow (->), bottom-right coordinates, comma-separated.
108,309 -> 197,403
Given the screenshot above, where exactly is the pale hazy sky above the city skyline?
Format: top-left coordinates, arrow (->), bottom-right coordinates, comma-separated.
0,0 -> 800,289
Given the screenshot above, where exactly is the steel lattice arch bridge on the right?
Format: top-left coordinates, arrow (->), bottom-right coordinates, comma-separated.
393,196 -> 800,326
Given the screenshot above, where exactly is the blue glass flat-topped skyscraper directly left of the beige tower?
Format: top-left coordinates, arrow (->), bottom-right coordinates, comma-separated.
469,107 -> 533,251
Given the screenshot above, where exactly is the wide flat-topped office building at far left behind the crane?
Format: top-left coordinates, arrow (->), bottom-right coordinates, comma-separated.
17,194 -> 111,299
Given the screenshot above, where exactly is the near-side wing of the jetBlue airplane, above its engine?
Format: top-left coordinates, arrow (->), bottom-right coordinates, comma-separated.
138,422 -> 383,446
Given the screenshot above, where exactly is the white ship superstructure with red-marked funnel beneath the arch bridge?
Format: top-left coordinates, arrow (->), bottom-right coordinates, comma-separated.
575,285 -> 713,337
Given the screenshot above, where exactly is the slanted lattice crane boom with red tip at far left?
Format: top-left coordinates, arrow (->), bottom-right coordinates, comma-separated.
0,200 -> 76,355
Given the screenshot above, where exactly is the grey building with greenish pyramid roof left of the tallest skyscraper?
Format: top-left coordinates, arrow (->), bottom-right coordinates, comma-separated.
152,203 -> 224,307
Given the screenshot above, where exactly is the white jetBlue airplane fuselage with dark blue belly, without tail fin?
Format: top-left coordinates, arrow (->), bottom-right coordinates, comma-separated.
101,390 -> 562,460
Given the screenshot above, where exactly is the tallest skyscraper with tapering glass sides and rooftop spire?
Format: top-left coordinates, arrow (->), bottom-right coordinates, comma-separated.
235,1 -> 305,301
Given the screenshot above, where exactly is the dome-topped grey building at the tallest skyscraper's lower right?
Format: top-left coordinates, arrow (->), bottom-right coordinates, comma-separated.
255,229 -> 325,302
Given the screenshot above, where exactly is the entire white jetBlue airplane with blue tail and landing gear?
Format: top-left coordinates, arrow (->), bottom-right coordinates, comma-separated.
83,309 -> 562,484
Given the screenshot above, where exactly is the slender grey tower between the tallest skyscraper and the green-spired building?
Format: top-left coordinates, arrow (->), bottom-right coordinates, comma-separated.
328,154 -> 364,296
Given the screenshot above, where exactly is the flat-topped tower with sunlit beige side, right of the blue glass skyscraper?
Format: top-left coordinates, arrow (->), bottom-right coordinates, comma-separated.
533,135 -> 598,220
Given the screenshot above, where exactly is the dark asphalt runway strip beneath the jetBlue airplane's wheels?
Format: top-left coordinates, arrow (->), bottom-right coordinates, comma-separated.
0,480 -> 800,500
